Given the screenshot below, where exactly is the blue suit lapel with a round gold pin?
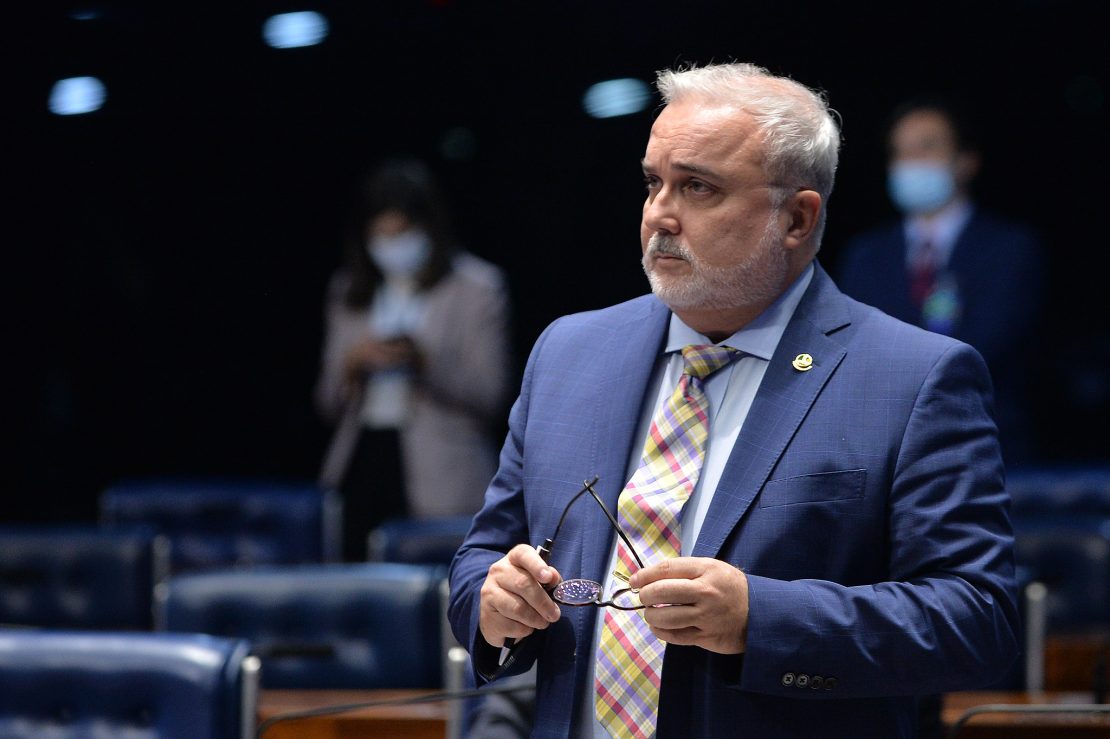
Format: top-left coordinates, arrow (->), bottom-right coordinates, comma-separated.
692,265 -> 850,557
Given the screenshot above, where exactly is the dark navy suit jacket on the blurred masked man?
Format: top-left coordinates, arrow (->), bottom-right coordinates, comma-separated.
837,210 -> 1046,463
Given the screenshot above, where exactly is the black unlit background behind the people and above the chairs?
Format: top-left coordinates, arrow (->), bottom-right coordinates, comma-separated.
2,0 -> 1110,519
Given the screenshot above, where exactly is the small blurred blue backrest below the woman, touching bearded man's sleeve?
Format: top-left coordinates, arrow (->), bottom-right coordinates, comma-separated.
366,516 -> 474,565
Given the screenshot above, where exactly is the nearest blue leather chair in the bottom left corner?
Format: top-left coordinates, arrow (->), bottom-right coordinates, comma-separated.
0,629 -> 258,739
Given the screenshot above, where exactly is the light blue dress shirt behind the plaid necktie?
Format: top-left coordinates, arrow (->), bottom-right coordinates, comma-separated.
582,264 -> 814,739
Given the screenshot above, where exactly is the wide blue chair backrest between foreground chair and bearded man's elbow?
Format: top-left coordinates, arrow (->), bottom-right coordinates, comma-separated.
158,563 -> 446,689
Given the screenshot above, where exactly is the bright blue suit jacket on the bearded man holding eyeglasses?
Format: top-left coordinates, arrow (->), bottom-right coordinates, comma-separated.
450,261 -> 1017,737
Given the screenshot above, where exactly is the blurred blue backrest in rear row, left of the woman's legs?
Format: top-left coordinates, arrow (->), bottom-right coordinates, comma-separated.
99,478 -> 341,573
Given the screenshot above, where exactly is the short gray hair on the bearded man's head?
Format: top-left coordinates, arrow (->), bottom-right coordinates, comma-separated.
656,63 -> 840,246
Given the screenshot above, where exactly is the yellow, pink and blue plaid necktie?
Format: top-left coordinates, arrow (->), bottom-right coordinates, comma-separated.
594,344 -> 737,738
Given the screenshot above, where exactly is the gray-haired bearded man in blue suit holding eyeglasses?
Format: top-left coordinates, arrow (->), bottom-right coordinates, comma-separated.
450,64 -> 1017,737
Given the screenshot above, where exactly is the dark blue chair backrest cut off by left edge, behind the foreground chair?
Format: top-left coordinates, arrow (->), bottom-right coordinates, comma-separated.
0,525 -> 168,629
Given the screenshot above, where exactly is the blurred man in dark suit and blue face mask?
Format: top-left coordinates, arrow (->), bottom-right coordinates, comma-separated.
837,98 -> 1045,465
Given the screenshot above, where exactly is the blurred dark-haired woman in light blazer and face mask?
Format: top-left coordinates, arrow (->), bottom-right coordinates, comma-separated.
315,160 -> 511,560
